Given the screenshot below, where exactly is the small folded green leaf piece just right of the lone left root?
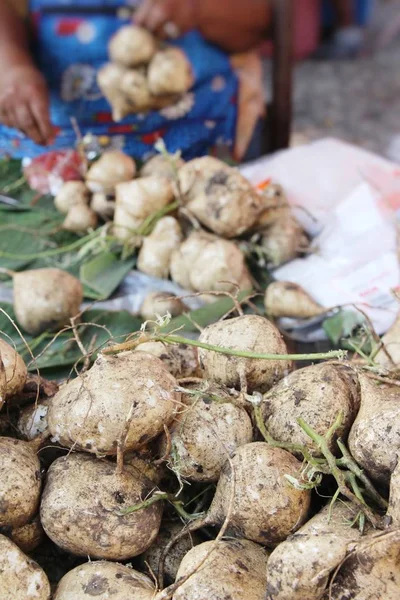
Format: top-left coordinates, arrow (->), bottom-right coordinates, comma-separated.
79,252 -> 135,300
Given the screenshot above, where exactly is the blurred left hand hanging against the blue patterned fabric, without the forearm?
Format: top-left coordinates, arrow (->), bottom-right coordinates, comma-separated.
0,65 -> 54,146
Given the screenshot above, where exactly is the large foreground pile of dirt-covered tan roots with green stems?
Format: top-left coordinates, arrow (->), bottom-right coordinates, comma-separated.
0,304 -> 400,600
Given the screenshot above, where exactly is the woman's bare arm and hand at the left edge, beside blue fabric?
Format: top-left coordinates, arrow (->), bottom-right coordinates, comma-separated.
0,0 -> 53,144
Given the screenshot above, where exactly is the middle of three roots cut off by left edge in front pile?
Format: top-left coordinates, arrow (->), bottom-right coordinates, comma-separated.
0,437 -> 41,528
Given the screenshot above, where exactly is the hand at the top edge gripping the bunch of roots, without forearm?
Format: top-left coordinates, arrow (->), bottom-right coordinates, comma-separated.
135,0 -> 199,37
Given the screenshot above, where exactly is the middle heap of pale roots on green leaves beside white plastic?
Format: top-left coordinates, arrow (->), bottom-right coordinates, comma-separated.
55,151 -> 310,304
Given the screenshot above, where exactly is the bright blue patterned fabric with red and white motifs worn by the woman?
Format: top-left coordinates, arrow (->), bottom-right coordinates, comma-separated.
0,0 -> 238,159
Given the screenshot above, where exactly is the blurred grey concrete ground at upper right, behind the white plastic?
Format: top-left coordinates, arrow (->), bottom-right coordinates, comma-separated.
286,0 -> 400,162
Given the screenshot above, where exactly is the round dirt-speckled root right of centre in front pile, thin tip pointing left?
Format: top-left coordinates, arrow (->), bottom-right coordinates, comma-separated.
207,442 -> 310,546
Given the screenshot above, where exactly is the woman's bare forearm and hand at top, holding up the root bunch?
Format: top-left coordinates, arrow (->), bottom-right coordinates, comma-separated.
135,0 -> 271,52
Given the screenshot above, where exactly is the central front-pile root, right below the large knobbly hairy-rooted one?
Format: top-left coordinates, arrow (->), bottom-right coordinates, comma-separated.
161,392 -> 253,482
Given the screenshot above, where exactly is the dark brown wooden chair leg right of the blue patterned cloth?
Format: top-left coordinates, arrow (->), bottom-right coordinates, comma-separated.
263,0 -> 294,154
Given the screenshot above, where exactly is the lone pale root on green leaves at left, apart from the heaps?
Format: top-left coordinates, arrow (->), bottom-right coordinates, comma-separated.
14,269 -> 83,335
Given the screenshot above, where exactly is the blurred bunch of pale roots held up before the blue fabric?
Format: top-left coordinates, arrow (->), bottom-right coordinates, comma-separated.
97,25 -> 194,121
